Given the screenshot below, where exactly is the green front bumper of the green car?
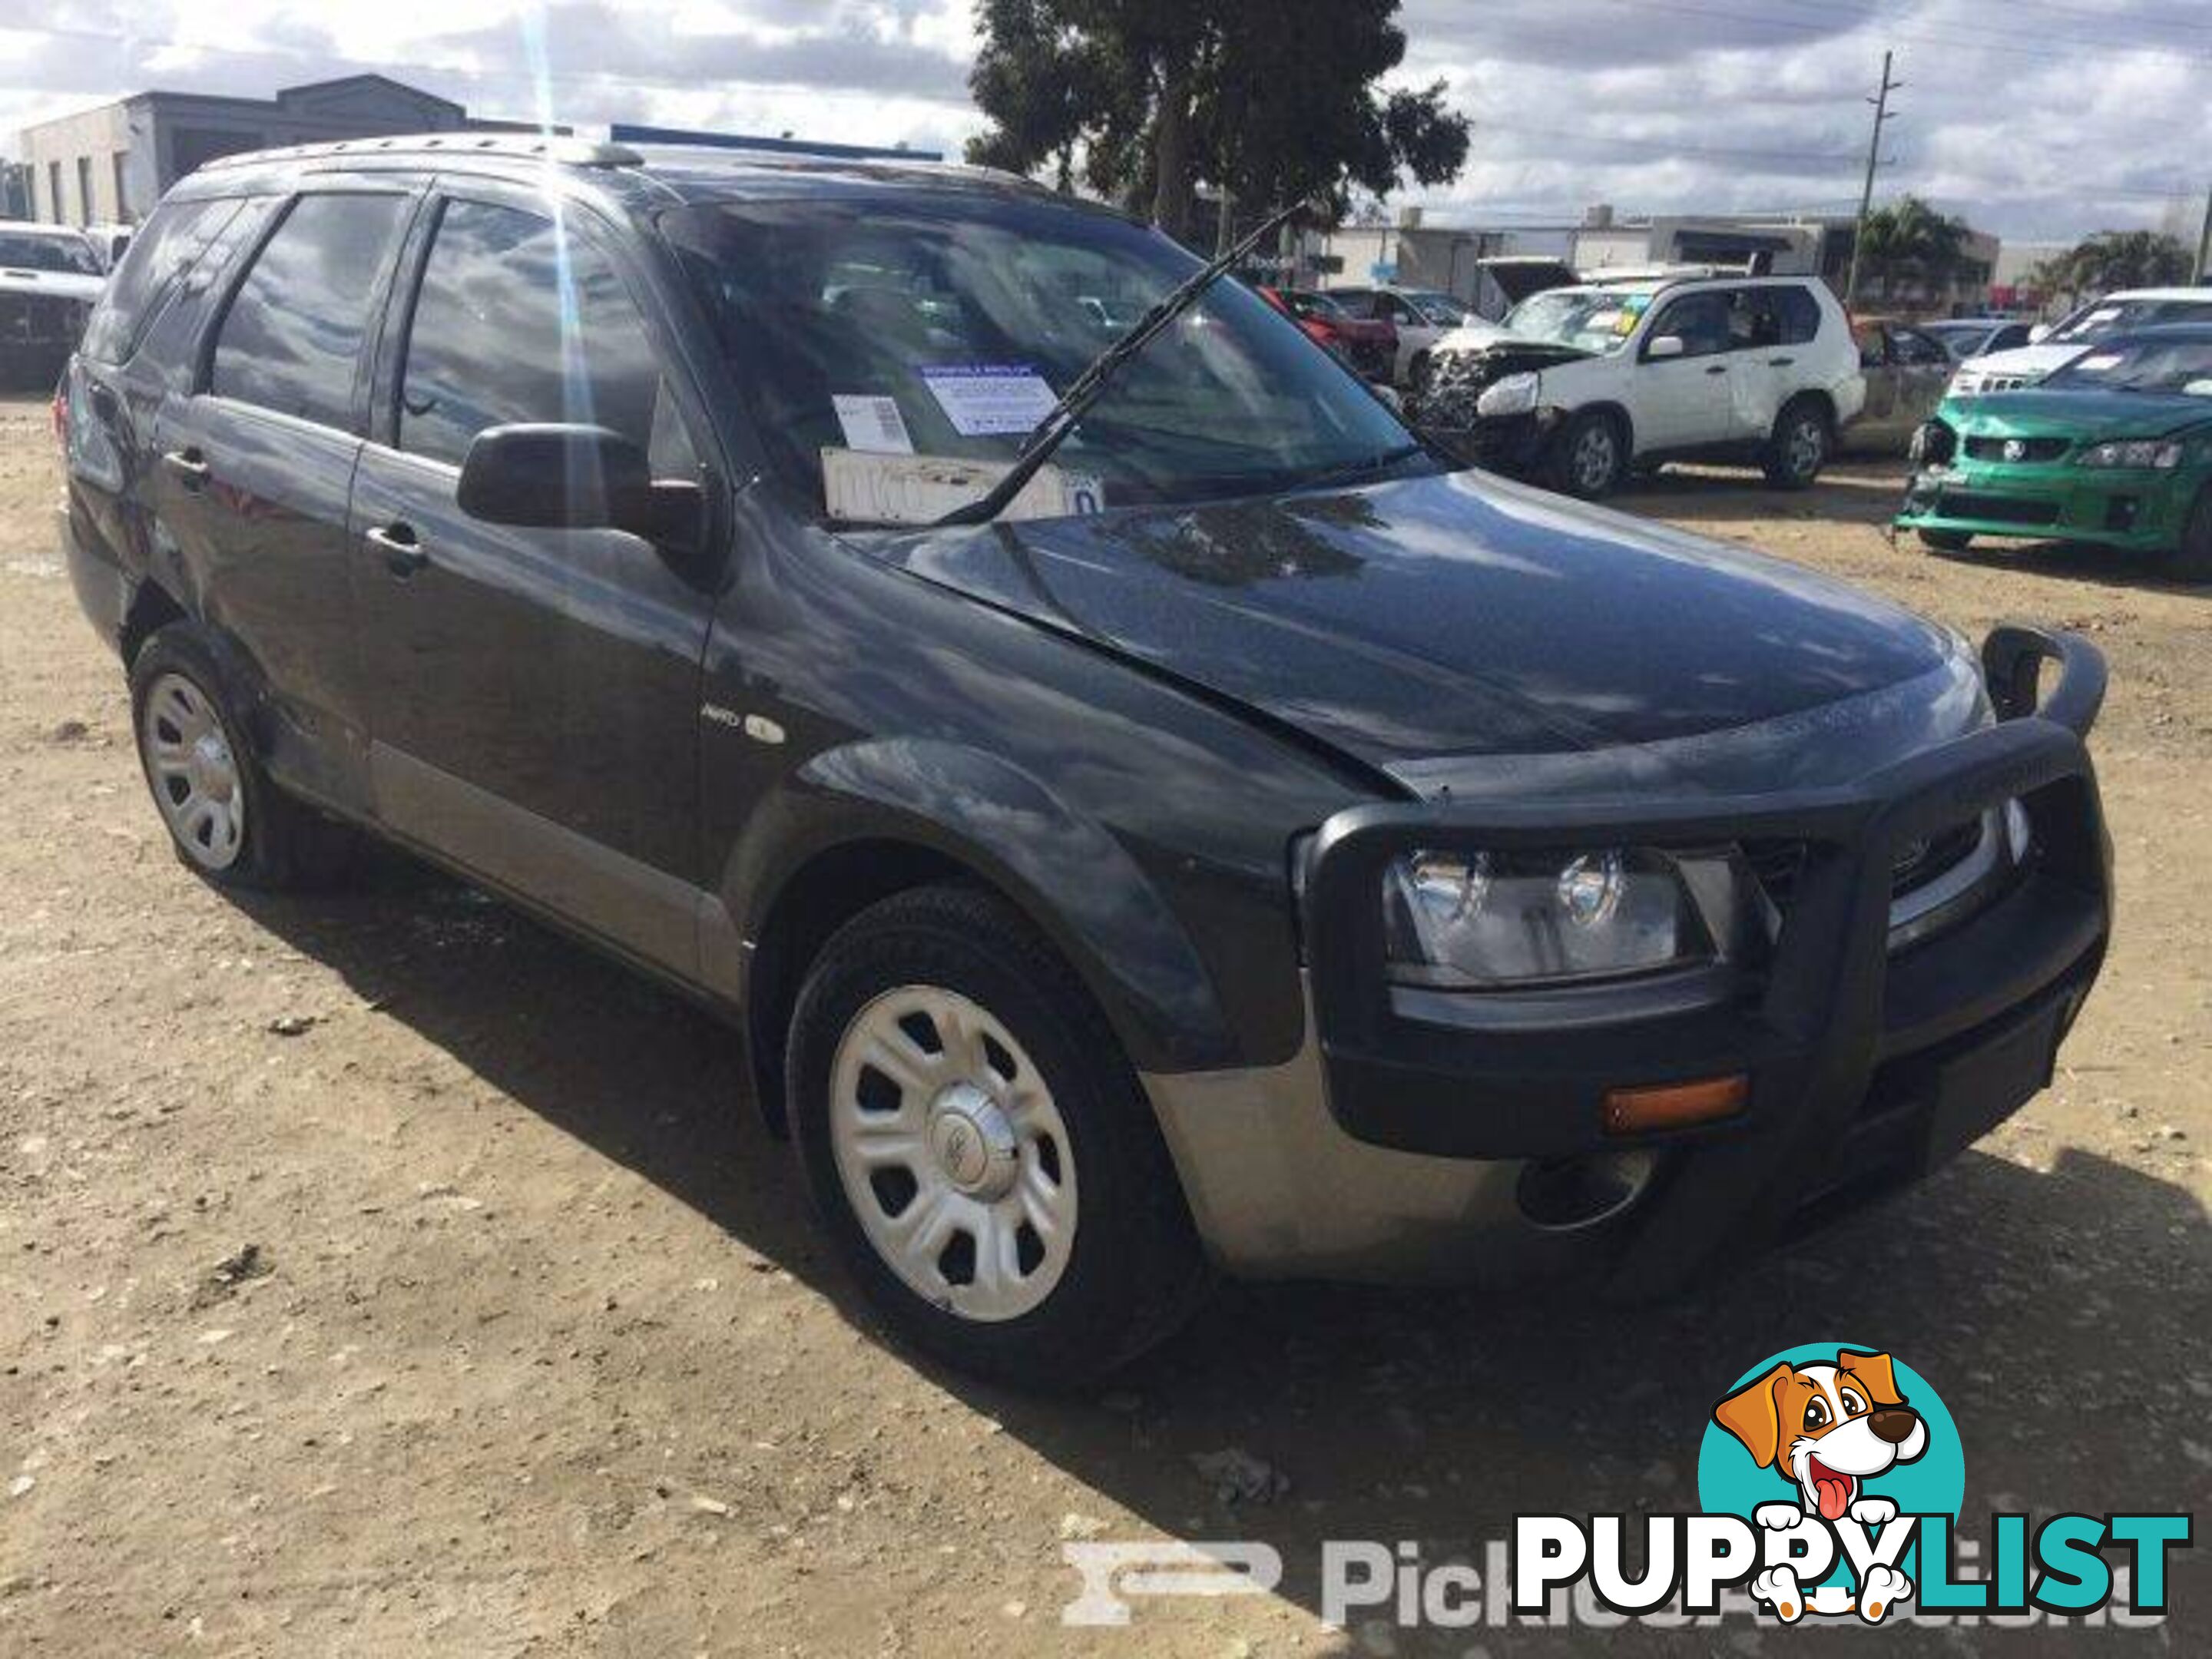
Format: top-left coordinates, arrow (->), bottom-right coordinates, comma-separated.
1898,462 -> 2194,551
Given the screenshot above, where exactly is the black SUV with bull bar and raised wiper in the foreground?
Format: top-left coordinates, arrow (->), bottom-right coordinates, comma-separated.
62,135 -> 2108,1378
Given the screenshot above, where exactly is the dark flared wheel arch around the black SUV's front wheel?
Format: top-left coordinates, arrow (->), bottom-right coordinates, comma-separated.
724,739 -> 1241,1126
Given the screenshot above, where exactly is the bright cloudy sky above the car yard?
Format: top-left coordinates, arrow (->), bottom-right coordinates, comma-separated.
0,0 -> 2212,241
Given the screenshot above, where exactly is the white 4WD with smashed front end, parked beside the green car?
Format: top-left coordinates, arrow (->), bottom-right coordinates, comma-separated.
1411,274 -> 1867,500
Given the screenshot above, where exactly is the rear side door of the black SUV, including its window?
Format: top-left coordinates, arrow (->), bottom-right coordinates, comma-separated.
148,181 -> 418,810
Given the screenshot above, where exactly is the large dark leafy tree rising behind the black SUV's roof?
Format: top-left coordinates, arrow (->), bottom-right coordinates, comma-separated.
969,0 -> 1469,239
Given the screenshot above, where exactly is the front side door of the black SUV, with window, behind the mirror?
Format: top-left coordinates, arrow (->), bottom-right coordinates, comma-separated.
352,188 -> 710,971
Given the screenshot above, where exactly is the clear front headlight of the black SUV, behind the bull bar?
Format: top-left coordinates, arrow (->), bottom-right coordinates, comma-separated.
1382,847 -> 1727,988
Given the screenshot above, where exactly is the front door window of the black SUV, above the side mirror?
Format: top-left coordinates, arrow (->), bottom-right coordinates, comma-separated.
398,201 -> 697,475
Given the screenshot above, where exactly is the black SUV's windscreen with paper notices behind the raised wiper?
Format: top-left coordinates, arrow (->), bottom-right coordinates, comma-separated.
661,190 -> 1411,522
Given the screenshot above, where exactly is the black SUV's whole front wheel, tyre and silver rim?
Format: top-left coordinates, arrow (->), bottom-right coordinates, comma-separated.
785,885 -> 1207,1387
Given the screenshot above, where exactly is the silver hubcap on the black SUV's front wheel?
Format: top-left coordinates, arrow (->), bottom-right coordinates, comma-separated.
830,985 -> 1078,1320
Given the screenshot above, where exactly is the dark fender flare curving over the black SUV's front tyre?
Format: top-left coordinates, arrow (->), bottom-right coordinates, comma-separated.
721,739 -> 1241,1071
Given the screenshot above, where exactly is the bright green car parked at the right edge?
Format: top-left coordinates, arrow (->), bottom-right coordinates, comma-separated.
1898,325 -> 2212,581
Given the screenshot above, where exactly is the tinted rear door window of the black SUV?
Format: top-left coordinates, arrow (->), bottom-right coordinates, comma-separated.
208,194 -> 409,429
